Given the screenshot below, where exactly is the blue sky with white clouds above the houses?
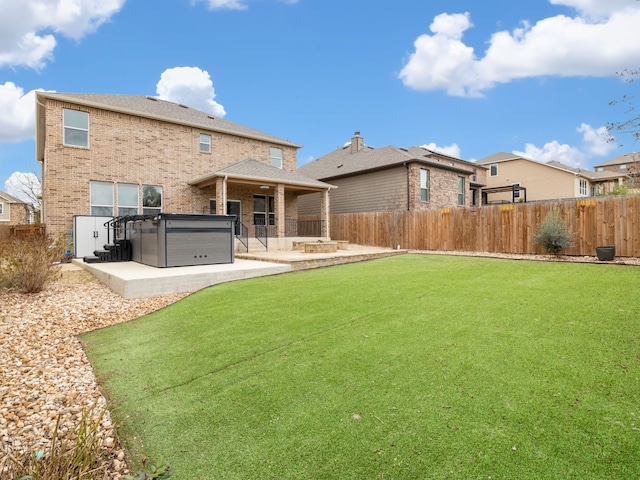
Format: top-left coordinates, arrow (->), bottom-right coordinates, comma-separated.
0,0 -> 640,199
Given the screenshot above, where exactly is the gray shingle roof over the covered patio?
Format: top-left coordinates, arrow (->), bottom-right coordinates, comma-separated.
189,159 -> 332,189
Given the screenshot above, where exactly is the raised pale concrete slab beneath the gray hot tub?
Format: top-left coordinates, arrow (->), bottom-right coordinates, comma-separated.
73,259 -> 293,298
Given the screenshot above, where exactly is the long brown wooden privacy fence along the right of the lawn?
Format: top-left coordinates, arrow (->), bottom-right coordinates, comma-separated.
318,195 -> 640,257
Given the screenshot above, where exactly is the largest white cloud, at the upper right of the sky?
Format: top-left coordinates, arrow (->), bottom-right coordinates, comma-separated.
398,0 -> 640,96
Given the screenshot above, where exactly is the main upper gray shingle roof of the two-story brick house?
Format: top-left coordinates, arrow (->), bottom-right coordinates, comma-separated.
38,92 -> 300,148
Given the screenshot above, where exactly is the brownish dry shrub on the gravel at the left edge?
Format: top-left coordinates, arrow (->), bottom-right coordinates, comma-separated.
0,235 -> 65,293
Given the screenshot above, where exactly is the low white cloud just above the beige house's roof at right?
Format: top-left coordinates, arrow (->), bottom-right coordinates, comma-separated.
513,123 -> 616,168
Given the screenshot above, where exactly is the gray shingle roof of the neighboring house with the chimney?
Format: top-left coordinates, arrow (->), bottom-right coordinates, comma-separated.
298,144 -> 474,180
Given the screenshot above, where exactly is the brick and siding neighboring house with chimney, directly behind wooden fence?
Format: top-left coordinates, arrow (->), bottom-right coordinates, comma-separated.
298,132 -> 486,215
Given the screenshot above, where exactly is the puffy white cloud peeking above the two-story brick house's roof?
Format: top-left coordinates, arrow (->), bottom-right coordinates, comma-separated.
156,67 -> 227,117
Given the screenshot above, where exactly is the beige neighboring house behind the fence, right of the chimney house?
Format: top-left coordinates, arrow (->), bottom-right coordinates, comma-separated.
478,152 -> 626,203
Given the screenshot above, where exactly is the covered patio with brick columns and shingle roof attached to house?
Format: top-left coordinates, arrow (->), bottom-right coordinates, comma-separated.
188,159 -> 336,251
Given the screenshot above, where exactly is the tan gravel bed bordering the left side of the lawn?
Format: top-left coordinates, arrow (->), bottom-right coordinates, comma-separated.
0,265 -> 187,478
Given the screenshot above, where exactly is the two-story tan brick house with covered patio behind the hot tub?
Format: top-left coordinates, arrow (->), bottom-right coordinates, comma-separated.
36,92 -> 331,246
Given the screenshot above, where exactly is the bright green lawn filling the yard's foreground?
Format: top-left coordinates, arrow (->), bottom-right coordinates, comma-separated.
82,255 -> 640,480
